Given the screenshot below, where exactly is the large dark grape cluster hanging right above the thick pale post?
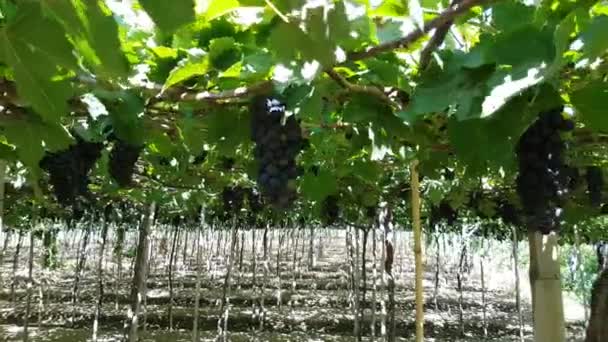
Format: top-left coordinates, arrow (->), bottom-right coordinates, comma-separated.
516,106 -> 575,234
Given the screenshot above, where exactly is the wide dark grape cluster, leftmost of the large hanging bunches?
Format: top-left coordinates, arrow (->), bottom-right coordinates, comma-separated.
39,135 -> 103,206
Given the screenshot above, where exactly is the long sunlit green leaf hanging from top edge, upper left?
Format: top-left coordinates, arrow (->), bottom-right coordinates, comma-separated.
42,0 -> 129,78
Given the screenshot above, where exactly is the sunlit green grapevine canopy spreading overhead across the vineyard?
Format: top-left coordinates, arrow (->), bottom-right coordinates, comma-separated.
0,0 -> 608,235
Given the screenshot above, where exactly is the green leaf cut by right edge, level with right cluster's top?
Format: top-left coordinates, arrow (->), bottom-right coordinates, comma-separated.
570,80 -> 608,132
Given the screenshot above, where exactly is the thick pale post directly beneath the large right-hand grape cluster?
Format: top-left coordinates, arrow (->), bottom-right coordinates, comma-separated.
529,231 -> 565,342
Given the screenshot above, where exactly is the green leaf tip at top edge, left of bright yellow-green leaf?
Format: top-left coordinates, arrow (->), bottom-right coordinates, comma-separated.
139,0 -> 195,34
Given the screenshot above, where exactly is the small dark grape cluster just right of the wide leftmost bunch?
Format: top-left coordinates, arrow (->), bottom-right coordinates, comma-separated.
109,140 -> 143,188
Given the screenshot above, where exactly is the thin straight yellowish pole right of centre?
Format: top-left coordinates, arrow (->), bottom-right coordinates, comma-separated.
410,160 -> 424,342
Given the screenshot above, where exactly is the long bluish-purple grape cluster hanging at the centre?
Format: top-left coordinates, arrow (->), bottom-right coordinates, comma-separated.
250,97 -> 306,208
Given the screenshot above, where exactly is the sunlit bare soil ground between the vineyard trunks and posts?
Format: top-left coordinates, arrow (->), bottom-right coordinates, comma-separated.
0,230 -> 583,342
